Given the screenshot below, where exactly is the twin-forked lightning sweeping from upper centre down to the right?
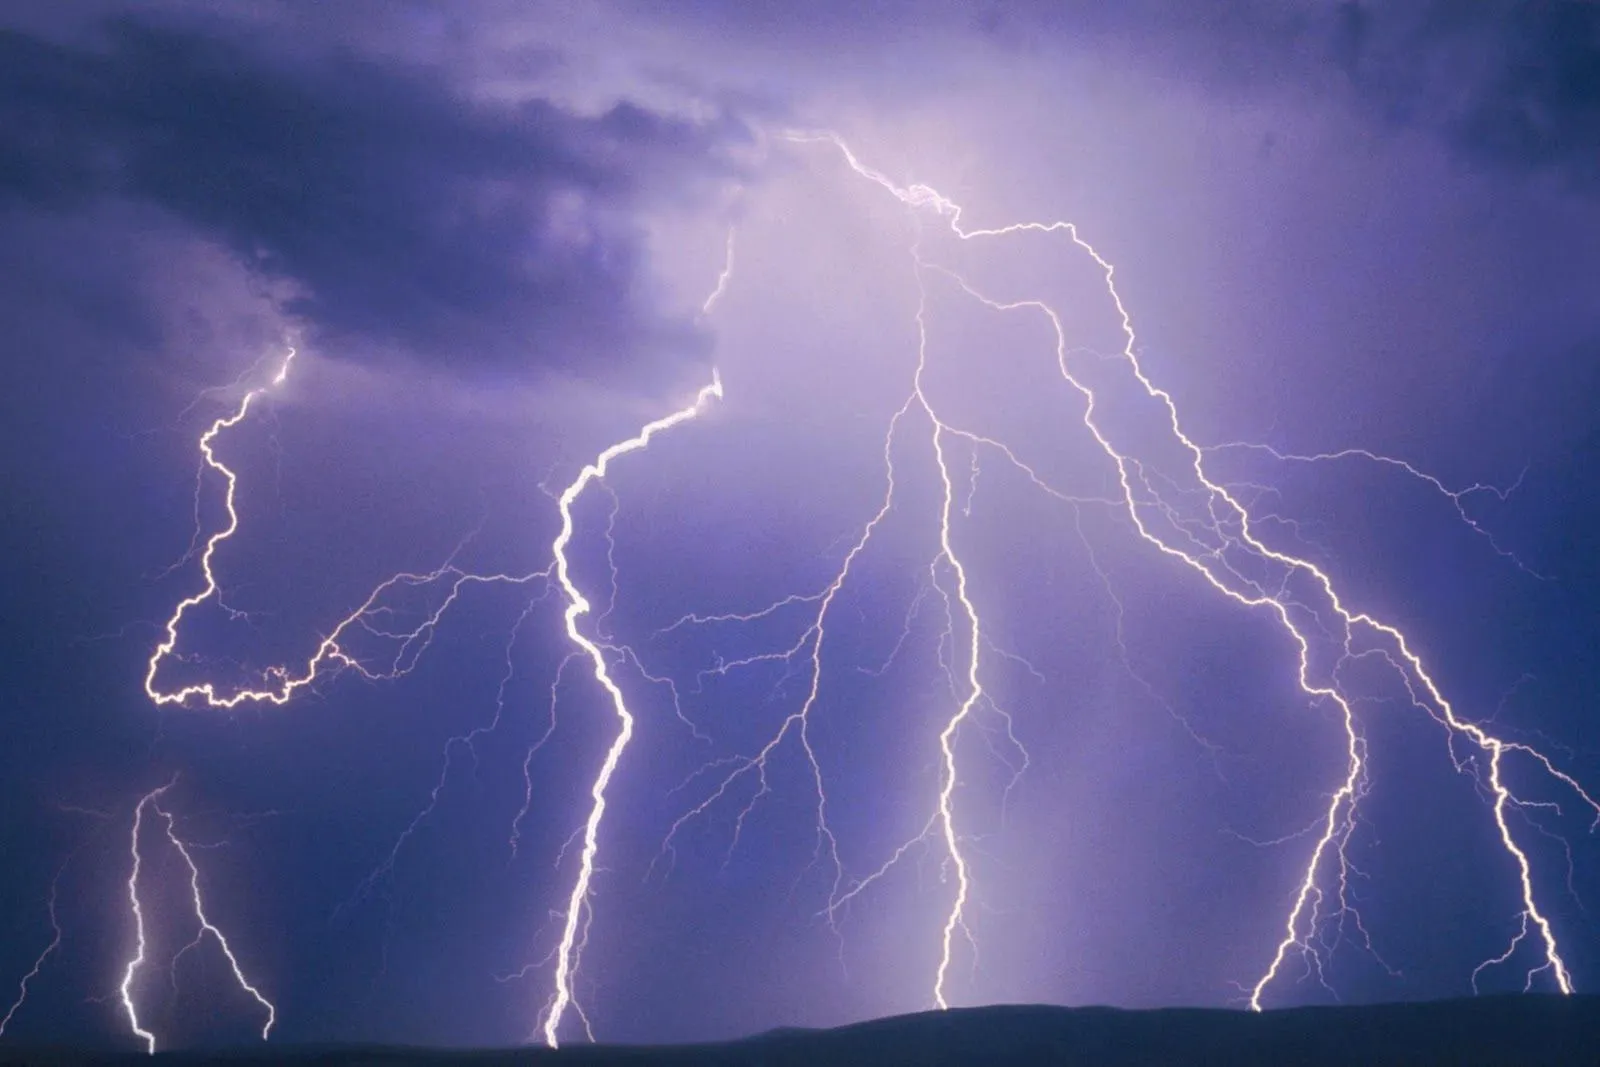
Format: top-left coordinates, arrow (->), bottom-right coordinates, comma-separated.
786,131 -> 1600,1011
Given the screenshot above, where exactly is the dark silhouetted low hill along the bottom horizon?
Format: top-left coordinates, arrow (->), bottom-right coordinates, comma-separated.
0,997 -> 1600,1067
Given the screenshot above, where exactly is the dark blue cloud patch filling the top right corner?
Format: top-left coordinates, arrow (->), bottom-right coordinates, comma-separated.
1040,0 -> 1600,190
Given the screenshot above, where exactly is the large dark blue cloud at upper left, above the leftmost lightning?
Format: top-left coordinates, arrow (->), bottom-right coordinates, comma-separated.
0,21 -> 742,377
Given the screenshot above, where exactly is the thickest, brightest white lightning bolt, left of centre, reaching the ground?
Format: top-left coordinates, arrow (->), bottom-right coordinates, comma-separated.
542,371 -> 731,1048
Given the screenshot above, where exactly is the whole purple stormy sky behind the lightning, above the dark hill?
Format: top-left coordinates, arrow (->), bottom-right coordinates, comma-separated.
0,0 -> 1600,1048
